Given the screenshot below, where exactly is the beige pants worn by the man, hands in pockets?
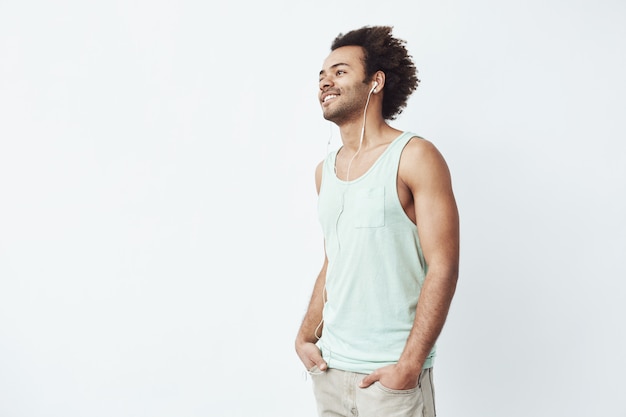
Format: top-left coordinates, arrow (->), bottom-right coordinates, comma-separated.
311,368 -> 436,417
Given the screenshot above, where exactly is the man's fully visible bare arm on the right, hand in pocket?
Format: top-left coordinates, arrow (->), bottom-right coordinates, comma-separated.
361,139 -> 459,390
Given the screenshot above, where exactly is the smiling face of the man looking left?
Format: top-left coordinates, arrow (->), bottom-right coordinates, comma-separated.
318,46 -> 371,125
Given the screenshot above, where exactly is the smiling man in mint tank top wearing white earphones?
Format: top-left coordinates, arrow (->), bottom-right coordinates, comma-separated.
295,26 -> 459,417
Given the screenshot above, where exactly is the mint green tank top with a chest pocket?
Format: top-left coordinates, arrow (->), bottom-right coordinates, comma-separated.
318,132 -> 436,373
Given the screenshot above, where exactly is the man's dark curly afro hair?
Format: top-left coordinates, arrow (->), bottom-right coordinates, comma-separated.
330,26 -> 420,120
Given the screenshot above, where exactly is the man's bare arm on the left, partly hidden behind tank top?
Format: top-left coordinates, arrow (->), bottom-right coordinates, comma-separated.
296,163 -> 328,370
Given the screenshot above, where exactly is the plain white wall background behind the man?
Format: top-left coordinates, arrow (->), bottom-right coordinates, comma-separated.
0,0 -> 626,417
